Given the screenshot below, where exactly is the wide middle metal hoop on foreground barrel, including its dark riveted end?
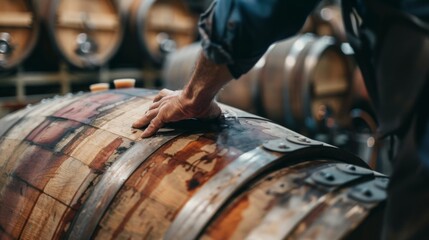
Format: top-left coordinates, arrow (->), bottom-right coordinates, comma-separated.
164,133 -> 365,240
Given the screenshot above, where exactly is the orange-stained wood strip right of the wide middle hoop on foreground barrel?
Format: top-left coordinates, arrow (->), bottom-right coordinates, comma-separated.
202,161 -> 326,239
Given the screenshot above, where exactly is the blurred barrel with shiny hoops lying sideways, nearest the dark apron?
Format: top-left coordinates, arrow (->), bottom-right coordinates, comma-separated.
260,34 -> 353,132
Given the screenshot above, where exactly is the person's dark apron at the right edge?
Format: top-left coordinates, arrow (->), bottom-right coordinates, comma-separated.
343,0 -> 429,239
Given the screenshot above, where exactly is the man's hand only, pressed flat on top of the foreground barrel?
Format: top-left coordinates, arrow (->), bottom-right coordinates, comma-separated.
133,89 -> 221,138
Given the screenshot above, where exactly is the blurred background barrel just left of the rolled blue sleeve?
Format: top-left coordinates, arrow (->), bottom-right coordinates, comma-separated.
112,0 -> 198,68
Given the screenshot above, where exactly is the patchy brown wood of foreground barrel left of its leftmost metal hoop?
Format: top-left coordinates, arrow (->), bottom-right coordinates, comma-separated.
0,93 -> 148,238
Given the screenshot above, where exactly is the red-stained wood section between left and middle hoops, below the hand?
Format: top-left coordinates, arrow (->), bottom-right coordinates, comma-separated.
93,117 -> 294,239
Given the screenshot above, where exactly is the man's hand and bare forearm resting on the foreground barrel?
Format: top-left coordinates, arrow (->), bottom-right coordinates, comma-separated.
133,54 -> 232,137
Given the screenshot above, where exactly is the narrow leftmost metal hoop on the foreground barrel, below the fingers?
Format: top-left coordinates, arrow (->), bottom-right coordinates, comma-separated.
67,131 -> 183,240
